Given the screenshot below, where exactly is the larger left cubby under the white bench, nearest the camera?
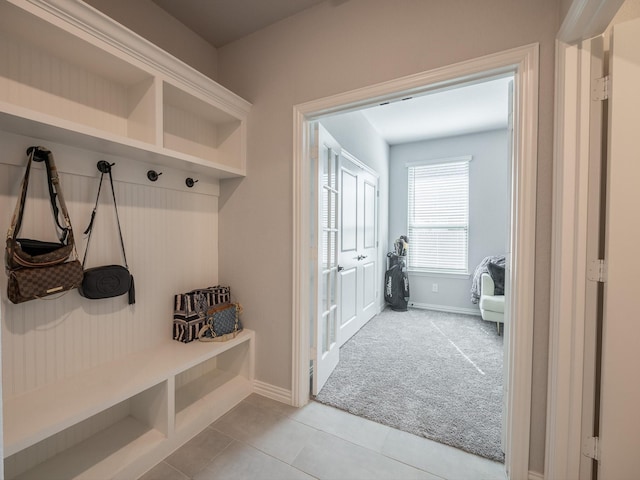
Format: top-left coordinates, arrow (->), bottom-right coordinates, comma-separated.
4,381 -> 169,480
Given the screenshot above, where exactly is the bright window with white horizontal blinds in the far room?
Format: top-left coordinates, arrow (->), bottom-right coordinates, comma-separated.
407,157 -> 471,274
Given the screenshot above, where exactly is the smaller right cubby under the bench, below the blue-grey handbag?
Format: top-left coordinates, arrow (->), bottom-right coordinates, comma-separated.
175,337 -> 253,431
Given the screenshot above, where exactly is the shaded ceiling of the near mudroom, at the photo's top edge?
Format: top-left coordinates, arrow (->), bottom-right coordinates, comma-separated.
153,0 -> 328,48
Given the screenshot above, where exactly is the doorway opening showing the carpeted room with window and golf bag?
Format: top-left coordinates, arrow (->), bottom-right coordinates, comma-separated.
310,74 -> 513,462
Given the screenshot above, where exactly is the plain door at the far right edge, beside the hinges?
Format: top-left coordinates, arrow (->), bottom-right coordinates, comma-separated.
598,15 -> 640,480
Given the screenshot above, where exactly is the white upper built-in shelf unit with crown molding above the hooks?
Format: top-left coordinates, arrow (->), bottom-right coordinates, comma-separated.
0,0 -> 251,178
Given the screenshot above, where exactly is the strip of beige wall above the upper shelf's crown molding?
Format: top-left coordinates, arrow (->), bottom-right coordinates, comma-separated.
85,0 -> 218,79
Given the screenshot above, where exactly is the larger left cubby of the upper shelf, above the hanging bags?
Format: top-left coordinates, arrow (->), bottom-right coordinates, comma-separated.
0,2 -> 157,144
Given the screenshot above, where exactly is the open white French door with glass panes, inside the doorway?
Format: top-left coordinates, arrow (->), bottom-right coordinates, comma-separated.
312,124 -> 342,395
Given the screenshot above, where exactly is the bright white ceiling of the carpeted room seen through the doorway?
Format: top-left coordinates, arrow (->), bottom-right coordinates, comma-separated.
362,76 -> 513,145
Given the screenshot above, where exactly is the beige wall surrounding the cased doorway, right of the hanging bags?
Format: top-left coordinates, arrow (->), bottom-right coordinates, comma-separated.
218,0 -> 560,472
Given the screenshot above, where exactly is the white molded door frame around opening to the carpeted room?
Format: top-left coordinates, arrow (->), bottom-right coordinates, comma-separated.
291,43 -> 539,478
